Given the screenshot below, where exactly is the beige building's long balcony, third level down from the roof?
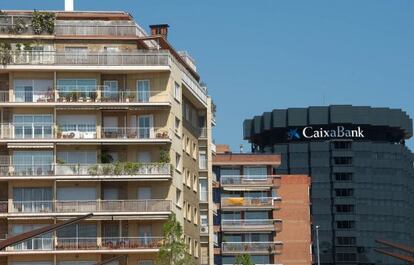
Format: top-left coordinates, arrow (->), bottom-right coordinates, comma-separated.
0,86 -> 171,106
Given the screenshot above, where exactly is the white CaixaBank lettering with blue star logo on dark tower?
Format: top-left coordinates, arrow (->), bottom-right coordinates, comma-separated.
287,125 -> 366,141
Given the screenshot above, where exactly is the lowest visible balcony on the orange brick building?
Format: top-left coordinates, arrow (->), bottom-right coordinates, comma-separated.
221,241 -> 283,255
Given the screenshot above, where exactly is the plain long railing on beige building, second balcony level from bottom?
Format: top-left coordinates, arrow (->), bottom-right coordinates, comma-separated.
8,199 -> 171,213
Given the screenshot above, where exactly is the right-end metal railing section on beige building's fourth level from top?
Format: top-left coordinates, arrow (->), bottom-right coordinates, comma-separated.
101,127 -> 172,139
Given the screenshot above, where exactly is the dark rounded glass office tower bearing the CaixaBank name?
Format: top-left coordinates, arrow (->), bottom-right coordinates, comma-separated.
244,105 -> 414,265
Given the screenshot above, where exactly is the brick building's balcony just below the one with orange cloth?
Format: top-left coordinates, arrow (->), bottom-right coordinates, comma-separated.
221,219 -> 282,232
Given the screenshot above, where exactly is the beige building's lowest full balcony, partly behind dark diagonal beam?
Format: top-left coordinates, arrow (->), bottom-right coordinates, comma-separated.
0,236 -> 163,255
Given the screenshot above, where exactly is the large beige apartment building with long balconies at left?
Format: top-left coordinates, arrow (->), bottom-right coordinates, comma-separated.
0,6 -> 214,265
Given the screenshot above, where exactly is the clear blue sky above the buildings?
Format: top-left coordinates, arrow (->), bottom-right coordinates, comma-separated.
0,0 -> 414,150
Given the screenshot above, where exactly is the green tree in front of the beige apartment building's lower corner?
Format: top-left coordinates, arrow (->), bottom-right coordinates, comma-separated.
157,214 -> 195,265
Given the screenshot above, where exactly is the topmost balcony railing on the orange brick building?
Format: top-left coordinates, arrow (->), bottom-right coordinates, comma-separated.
220,175 -> 276,186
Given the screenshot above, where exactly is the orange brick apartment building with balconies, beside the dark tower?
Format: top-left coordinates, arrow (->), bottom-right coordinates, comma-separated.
213,145 -> 311,265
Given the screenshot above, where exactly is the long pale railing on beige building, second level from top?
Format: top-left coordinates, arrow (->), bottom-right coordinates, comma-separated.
7,51 -> 170,66
